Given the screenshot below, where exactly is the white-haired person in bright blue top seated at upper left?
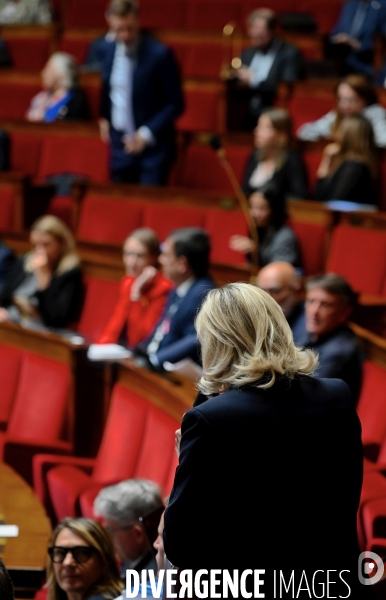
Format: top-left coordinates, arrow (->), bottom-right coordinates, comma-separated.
26,52 -> 90,123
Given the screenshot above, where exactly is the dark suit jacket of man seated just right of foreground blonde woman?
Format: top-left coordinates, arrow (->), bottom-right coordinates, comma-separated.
298,325 -> 363,403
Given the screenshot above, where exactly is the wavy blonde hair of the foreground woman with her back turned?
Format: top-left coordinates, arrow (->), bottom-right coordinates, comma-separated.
196,283 -> 317,396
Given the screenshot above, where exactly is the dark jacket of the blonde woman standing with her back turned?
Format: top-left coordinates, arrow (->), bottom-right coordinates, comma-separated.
164,376 -> 366,599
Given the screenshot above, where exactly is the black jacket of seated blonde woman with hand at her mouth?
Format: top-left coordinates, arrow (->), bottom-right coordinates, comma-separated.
0,256 -> 83,328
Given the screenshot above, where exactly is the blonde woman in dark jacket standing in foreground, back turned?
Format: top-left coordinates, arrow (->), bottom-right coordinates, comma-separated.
164,283 -> 367,598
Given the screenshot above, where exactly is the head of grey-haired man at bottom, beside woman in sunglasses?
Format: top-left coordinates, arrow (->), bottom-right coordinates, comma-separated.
94,479 -> 164,578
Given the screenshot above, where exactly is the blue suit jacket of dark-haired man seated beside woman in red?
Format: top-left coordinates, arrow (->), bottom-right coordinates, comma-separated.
144,277 -> 216,365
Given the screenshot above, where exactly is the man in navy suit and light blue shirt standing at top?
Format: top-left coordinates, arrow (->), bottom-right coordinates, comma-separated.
100,0 -> 184,185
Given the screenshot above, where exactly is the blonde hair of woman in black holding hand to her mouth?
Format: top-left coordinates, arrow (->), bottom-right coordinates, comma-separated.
25,215 -> 80,275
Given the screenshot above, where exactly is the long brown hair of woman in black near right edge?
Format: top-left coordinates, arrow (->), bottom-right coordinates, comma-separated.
329,115 -> 378,178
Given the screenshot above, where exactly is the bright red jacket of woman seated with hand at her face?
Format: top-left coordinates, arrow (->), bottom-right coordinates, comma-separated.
98,273 -> 173,348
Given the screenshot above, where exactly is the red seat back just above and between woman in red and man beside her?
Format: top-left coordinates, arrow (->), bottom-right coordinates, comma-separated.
143,204 -> 205,240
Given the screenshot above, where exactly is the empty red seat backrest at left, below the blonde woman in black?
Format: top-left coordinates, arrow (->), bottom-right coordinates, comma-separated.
7,352 -> 70,442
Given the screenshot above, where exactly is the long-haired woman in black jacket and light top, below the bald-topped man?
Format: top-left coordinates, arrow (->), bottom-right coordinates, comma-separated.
242,108 -> 308,198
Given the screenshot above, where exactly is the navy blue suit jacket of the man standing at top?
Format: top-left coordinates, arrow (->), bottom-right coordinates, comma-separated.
101,34 -> 184,144
